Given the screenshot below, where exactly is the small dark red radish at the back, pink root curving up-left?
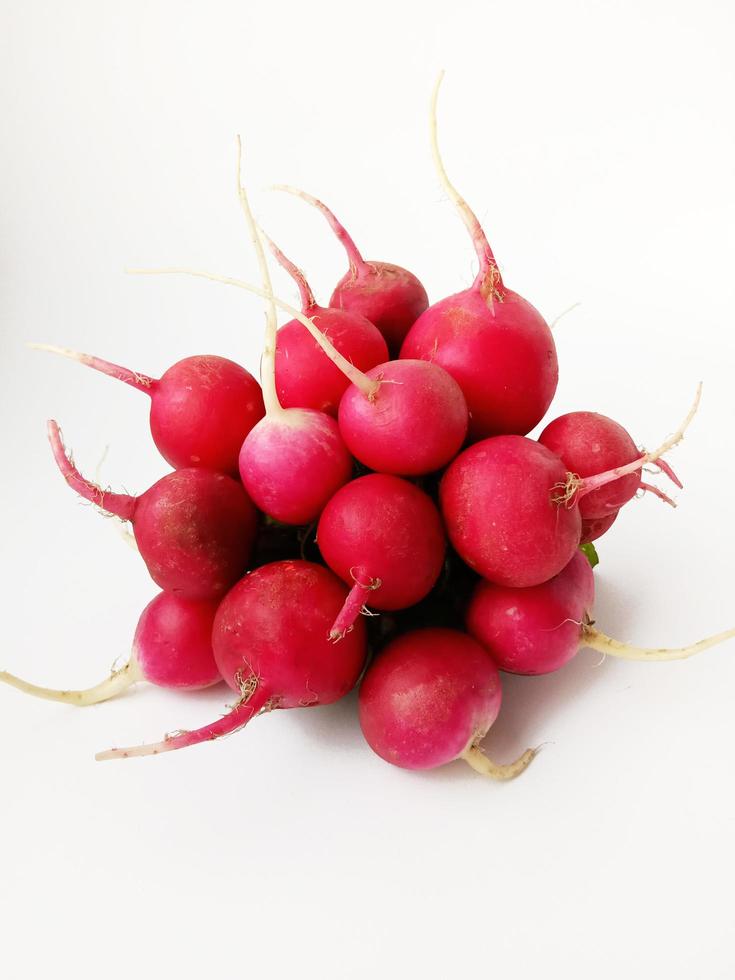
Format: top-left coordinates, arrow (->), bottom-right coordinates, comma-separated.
273,184 -> 429,359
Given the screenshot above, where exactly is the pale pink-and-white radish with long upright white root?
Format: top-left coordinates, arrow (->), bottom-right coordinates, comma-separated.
237,141 -> 352,524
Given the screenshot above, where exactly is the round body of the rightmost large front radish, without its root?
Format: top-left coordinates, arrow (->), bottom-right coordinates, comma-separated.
439,435 -> 582,587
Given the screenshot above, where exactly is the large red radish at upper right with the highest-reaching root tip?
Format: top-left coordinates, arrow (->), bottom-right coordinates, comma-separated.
401,75 -> 559,439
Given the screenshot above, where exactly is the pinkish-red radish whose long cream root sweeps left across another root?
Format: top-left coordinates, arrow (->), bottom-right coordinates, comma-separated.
137,267 -> 468,478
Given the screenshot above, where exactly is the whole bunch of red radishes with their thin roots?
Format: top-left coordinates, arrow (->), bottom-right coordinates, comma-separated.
0,78 -> 735,779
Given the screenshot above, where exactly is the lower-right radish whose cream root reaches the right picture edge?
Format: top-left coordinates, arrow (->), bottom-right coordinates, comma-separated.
467,552 -> 735,674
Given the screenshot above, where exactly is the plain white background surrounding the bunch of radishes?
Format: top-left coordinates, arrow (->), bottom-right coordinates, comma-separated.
0,0 -> 735,980
